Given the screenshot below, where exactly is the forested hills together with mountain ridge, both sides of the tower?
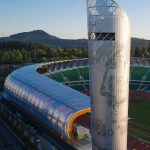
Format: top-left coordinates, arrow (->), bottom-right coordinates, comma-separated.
0,30 -> 150,64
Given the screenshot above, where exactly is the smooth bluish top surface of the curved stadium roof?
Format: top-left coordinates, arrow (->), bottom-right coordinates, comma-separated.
11,65 -> 90,111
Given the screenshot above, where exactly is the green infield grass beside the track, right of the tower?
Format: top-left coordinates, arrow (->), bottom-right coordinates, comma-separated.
128,94 -> 150,142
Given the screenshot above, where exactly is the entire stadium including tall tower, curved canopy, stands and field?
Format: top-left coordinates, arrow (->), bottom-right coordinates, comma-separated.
0,0 -> 150,150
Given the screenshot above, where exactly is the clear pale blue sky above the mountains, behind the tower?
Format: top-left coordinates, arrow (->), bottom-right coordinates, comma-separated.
0,0 -> 150,39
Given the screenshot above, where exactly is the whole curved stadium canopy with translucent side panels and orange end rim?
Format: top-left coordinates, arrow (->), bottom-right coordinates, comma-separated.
4,65 -> 90,143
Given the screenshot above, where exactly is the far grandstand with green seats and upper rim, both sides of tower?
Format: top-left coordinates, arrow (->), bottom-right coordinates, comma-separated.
46,58 -> 150,95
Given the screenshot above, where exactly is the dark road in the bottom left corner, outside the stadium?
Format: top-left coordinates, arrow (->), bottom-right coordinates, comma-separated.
0,120 -> 24,150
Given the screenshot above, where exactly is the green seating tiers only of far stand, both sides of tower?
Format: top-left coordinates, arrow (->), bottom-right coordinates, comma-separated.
49,67 -> 150,93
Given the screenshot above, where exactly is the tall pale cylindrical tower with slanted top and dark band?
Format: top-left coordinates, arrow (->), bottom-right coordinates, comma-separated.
87,0 -> 131,150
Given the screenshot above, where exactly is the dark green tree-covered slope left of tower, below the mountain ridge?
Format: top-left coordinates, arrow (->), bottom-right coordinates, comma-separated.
0,41 -> 88,64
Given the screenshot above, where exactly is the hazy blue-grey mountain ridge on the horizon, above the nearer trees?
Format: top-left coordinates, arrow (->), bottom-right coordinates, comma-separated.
0,30 -> 150,48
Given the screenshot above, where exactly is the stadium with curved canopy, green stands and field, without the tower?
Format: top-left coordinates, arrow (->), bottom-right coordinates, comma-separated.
3,58 -> 150,150
